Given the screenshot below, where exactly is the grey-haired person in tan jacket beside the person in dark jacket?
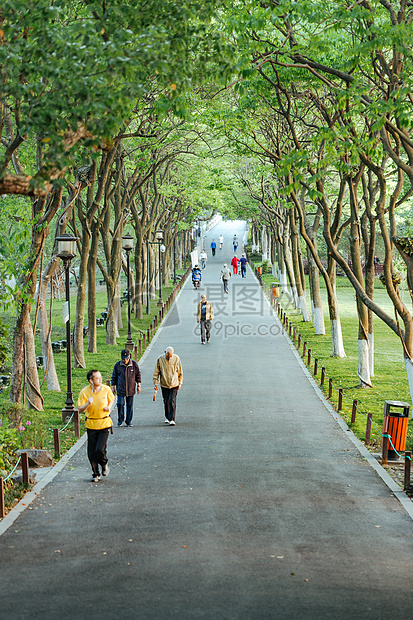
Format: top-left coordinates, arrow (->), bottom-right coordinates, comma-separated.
153,347 -> 183,426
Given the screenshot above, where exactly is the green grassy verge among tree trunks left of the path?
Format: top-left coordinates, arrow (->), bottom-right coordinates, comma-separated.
0,270 -> 185,512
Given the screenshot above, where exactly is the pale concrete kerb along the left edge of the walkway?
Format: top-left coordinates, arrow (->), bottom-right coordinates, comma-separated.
0,276 -> 185,536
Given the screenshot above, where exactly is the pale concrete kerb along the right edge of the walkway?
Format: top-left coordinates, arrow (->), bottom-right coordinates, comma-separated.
260,286 -> 413,520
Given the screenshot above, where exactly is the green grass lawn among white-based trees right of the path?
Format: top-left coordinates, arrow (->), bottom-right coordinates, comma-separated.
254,261 -> 413,451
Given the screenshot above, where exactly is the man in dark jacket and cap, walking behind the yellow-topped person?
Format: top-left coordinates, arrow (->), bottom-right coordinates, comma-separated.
110,349 -> 141,427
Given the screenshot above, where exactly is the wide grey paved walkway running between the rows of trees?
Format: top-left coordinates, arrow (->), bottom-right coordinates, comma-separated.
0,223 -> 413,620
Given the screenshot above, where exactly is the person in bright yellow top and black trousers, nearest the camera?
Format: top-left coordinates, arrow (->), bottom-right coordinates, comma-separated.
77,369 -> 115,482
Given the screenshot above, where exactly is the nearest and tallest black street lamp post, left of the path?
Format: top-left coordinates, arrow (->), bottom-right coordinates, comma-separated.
56,233 -> 78,420
